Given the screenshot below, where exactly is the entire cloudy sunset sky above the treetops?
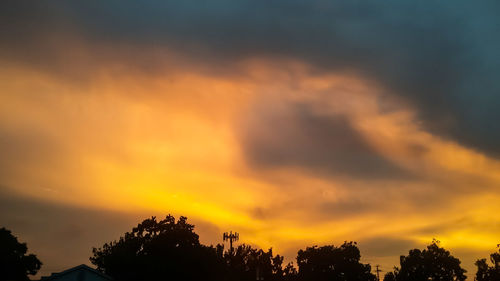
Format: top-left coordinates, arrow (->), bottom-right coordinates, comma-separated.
0,0 -> 500,279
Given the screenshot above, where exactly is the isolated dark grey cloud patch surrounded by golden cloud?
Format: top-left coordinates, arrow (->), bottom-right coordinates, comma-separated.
240,101 -> 410,179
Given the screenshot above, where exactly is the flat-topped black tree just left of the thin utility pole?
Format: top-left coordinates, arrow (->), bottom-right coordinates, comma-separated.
297,242 -> 376,281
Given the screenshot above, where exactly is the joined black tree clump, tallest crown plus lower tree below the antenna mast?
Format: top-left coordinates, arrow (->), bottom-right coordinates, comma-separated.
90,215 -> 294,281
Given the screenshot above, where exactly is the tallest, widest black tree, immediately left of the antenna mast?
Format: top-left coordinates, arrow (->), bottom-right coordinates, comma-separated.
90,215 -> 223,281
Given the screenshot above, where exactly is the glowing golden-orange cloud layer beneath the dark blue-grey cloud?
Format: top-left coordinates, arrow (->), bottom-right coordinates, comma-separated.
0,47 -> 500,274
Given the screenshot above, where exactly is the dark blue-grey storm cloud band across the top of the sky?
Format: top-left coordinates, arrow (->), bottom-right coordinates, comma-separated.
0,0 -> 500,155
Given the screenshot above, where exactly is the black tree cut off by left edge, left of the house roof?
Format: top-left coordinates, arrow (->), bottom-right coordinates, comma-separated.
0,228 -> 42,281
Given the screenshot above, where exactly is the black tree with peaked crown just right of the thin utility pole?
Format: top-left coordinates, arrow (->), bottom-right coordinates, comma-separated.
394,239 -> 467,281
